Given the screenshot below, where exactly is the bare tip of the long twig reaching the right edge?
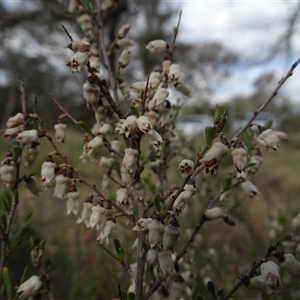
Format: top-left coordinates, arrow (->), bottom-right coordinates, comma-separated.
233,58 -> 300,138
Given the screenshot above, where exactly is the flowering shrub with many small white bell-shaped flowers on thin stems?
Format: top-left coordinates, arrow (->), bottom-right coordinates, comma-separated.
0,0 -> 300,300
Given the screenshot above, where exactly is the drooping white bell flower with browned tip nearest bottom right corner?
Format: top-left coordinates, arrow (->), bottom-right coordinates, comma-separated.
260,261 -> 282,296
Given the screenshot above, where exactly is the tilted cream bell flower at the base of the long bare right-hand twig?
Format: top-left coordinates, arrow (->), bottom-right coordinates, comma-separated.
200,142 -> 228,172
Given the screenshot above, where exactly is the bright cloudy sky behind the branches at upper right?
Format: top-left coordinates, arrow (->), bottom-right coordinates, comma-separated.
178,1 -> 300,103
